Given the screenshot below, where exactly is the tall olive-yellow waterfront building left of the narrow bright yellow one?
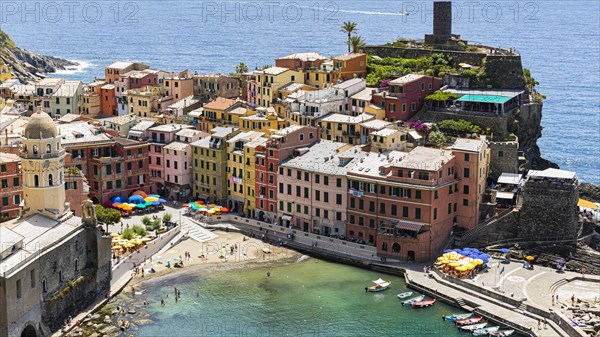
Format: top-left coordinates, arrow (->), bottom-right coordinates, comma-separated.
190,127 -> 240,203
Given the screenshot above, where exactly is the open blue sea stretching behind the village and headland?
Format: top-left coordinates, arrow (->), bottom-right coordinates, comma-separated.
0,0 -> 600,183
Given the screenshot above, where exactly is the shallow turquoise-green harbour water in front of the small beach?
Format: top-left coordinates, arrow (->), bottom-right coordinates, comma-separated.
121,259 -> 524,337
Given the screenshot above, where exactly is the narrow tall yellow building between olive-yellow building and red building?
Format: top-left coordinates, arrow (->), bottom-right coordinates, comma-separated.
227,131 -> 266,216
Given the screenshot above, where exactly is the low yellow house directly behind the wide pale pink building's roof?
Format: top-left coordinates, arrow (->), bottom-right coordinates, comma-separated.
319,113 -> 375,145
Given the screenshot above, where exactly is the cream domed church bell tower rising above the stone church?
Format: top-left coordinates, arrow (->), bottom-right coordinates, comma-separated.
20,109 -> 69,220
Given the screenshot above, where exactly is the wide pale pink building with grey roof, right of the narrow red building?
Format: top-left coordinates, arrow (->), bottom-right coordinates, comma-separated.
277,140 -> 368,236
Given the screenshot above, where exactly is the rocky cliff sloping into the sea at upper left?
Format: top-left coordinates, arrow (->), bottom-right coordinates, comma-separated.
0,30 -> 78,82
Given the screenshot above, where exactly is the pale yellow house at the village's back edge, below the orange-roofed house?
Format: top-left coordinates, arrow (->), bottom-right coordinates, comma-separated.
255,67 -> 304,108
